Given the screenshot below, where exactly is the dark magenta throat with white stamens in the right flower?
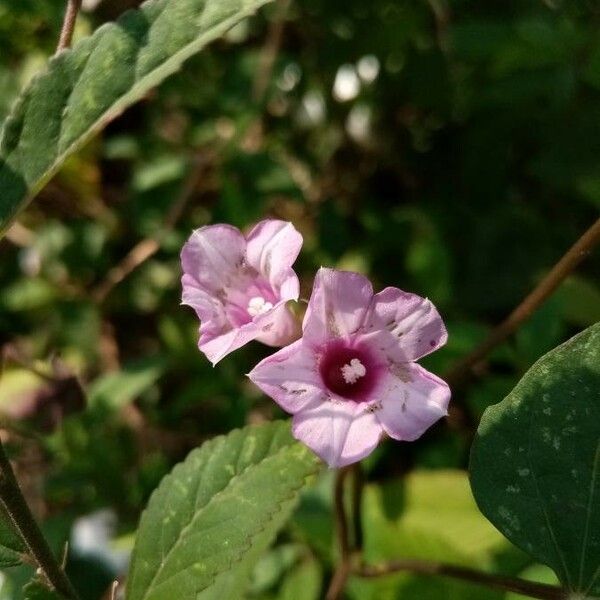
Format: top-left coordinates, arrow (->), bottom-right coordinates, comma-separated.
319,340 -> 381,402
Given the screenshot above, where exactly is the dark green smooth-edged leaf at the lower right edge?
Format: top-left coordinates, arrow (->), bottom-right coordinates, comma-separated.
471,323 -> 600,595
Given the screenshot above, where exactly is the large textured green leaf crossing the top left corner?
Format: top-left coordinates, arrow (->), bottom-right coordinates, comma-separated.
0,0 -> 270,237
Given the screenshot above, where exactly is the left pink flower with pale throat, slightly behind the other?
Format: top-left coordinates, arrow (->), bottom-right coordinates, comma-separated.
181,220 -> 302,365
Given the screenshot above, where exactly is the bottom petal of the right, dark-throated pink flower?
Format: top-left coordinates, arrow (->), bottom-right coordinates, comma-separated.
292,401 -> 382,467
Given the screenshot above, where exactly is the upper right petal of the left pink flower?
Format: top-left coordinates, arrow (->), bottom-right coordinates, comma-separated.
246,219 -> 302,292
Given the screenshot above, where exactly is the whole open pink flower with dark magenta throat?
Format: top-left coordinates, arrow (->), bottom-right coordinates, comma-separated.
249,268 -> 450,467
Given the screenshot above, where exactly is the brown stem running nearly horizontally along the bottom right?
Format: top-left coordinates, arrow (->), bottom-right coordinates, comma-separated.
356,559 -> 569,600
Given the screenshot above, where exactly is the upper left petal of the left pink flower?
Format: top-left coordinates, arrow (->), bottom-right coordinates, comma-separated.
181,225 -> 246,293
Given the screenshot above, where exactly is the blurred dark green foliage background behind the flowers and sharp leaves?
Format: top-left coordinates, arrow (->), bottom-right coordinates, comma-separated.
0,0 -> 600,600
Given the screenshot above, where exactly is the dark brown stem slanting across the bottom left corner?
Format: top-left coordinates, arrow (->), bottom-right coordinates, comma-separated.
0,440 -> 78,600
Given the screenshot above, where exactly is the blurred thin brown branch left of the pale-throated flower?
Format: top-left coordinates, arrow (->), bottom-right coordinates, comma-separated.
91,157 -> 206,304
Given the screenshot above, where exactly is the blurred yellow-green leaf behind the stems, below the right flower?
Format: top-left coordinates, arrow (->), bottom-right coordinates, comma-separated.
349,470 -> 523,600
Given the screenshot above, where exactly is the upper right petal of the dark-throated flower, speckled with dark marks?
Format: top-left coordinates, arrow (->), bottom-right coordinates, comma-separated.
363,287 -> 448,362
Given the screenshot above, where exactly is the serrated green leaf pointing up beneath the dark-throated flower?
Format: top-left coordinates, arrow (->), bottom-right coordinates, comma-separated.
127,422 -> 319,600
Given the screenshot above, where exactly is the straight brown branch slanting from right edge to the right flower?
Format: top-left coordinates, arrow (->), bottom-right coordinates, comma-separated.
444,219 -> 600,385
